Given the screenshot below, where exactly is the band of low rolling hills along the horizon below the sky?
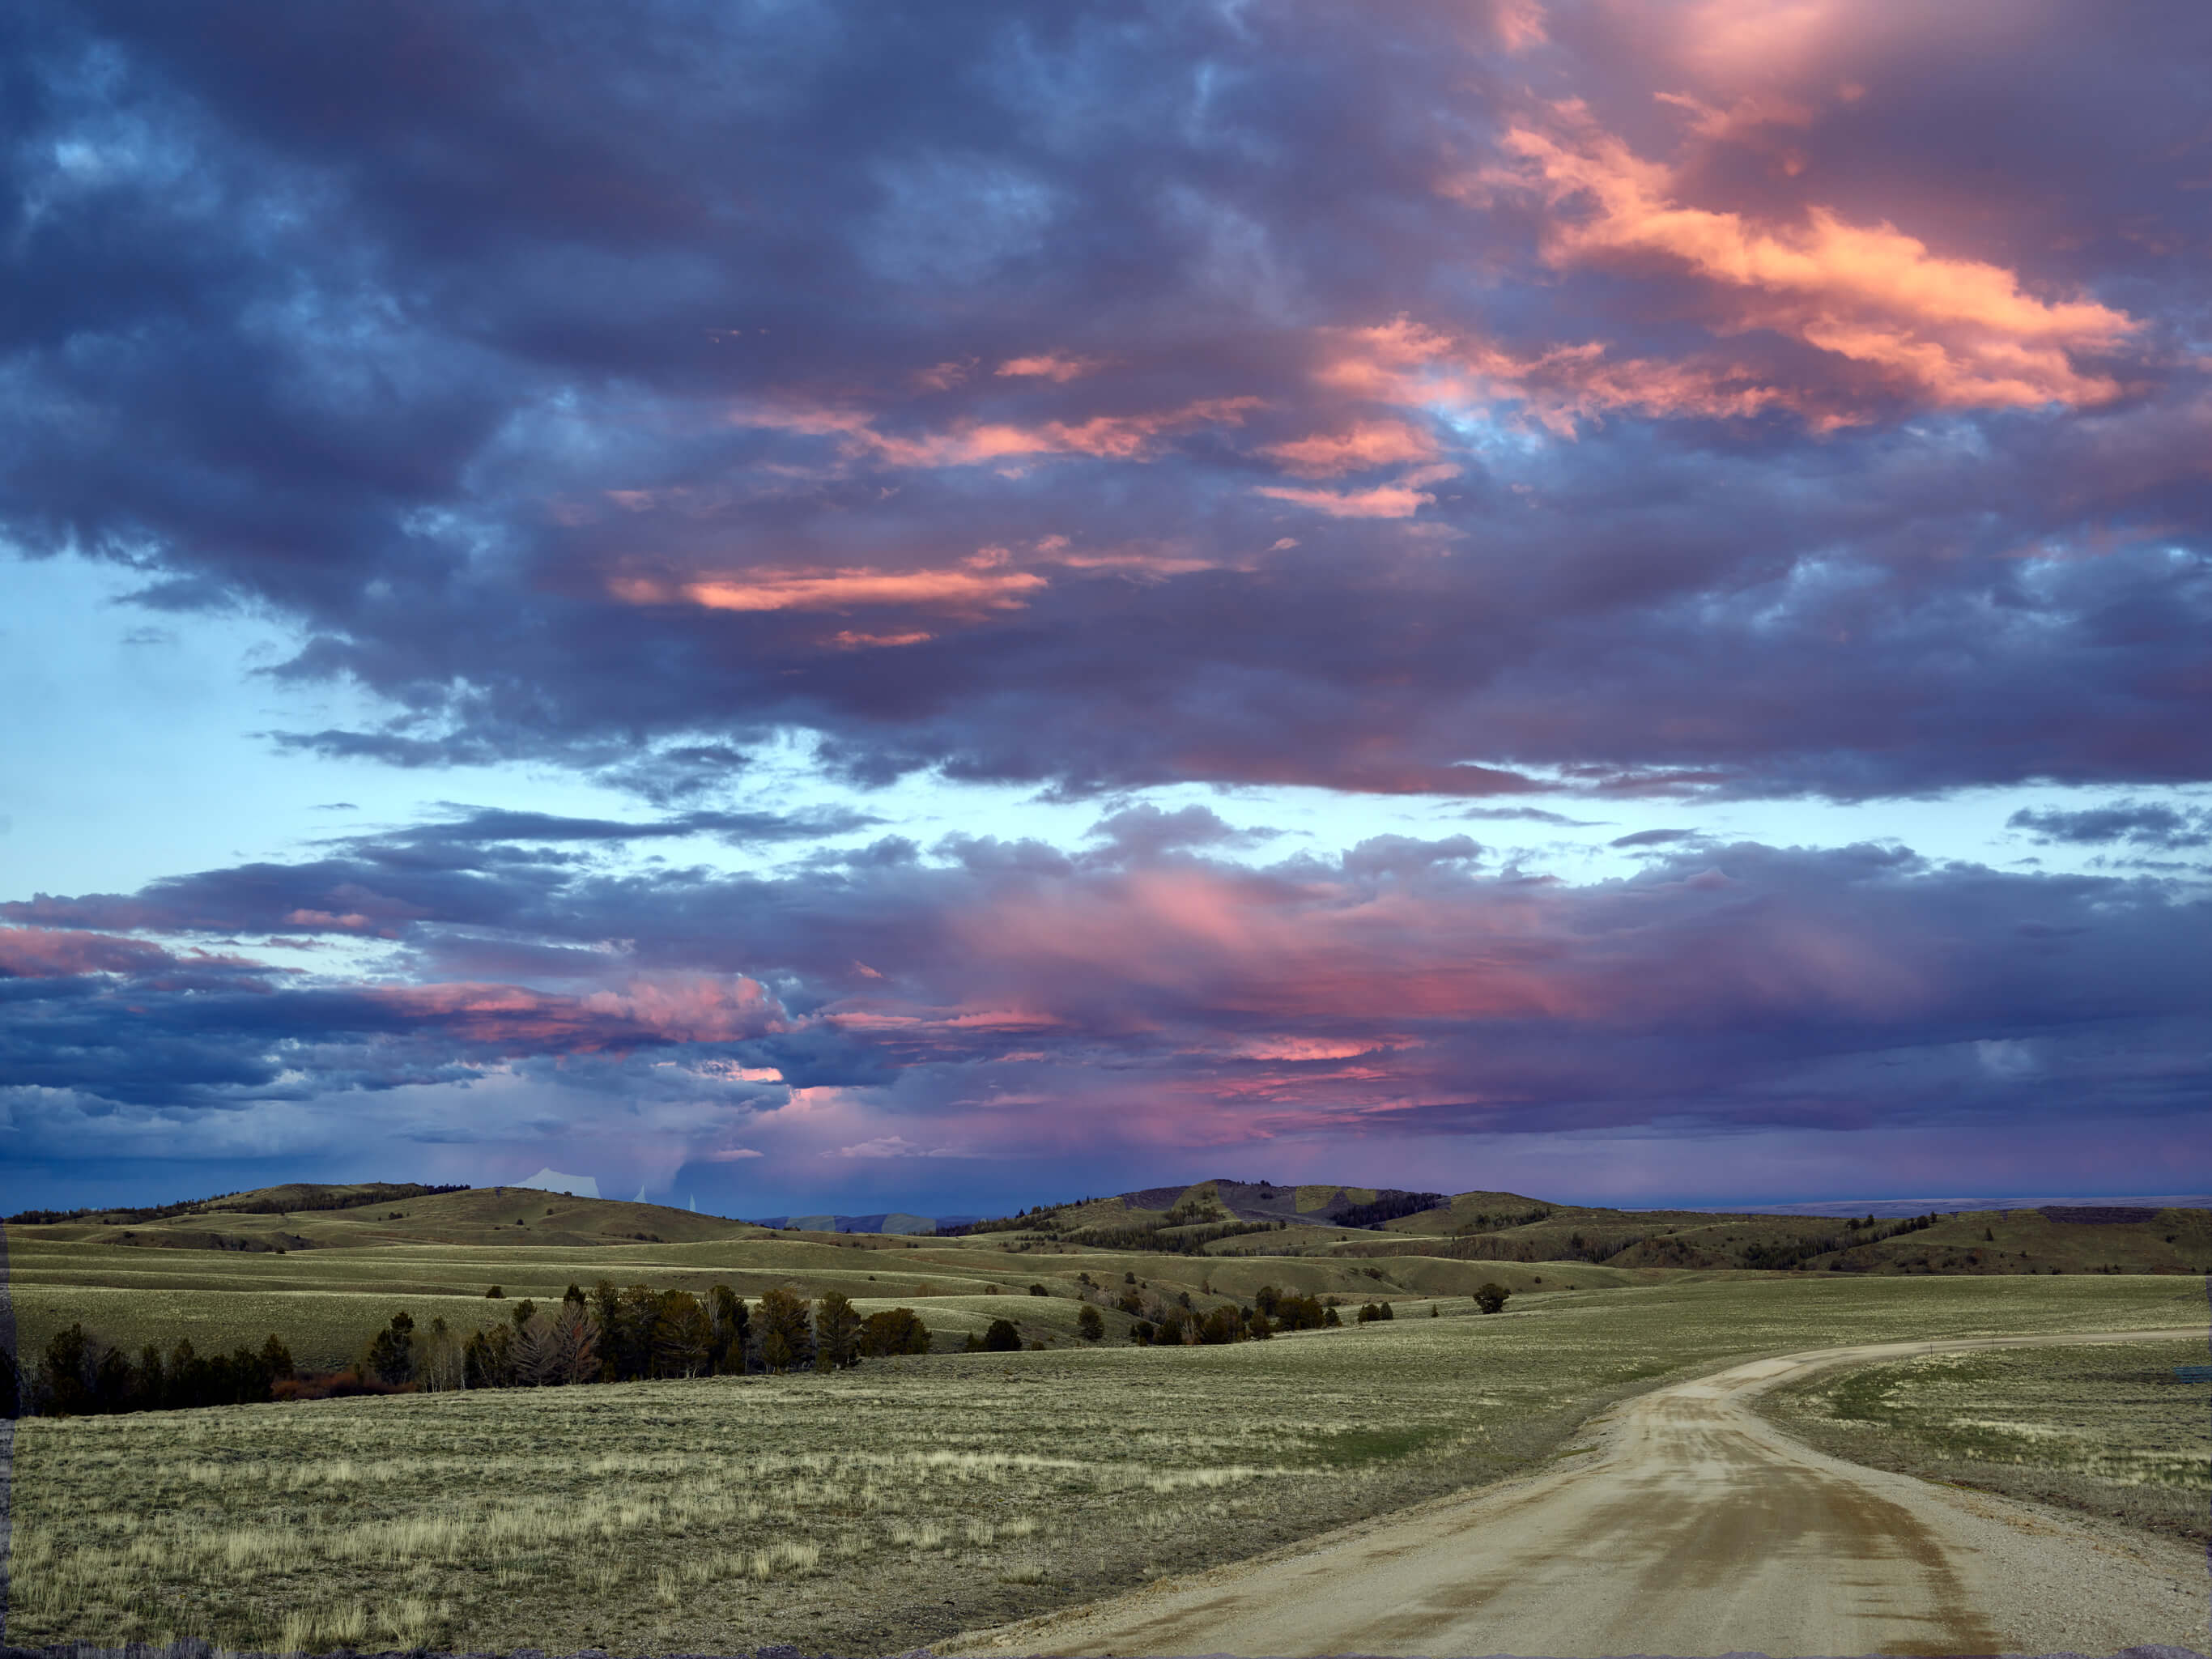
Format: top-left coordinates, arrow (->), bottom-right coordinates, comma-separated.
9,1179 -> 2212,1274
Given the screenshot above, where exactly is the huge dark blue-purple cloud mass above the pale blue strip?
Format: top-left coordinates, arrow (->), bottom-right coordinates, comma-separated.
0,0 -> 2212,805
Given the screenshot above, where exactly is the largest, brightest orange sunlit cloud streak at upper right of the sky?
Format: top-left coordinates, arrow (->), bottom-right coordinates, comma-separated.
1504,104 -> 2137,409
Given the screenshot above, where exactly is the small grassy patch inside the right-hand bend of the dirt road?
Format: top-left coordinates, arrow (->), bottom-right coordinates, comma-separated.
1763,1336 -> 2212,1542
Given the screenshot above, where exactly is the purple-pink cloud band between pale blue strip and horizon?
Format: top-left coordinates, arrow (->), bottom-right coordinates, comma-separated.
0,827 -> 2212,1157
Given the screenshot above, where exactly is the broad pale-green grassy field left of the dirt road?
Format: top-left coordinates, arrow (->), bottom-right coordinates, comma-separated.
9,1283 -> 2203,1655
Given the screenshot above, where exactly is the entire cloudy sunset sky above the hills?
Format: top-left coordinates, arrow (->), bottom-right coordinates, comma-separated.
0,0 -> 2212,1214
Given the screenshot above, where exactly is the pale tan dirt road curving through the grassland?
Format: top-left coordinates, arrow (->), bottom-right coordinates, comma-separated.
955,1327 -> 2208,1659
